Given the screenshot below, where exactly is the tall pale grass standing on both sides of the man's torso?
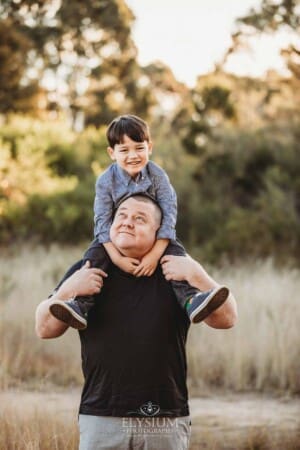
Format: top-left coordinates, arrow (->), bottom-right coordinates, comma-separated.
0,246 -> 300,393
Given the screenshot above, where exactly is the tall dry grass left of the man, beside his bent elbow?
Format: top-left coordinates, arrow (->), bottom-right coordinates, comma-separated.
0,246 -> 82,389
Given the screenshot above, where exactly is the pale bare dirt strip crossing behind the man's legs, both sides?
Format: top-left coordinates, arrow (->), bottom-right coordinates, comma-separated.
0,390 -> 300,450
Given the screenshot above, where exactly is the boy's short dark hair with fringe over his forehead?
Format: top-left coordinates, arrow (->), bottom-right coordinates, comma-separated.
106,114 -> 150,148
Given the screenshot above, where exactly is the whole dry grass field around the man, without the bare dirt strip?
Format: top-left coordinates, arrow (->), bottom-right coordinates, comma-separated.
0,245 -> 300,450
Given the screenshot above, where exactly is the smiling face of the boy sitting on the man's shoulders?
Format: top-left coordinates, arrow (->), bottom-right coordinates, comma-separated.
107,134 -> 152,178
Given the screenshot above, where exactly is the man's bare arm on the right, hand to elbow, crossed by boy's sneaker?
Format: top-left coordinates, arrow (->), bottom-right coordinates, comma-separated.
161,255 -> 237,329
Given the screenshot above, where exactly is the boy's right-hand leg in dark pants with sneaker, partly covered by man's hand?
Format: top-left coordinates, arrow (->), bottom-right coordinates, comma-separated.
164,240 -> 229,322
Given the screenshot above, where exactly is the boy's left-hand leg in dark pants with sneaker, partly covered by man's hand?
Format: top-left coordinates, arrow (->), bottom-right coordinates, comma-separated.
50,239 -> 110,330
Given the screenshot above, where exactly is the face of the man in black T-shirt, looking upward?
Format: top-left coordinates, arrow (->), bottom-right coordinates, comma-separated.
110,197 -> 159,259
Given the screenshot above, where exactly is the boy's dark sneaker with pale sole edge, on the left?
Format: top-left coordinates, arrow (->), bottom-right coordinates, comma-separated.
49,298 -> 87,330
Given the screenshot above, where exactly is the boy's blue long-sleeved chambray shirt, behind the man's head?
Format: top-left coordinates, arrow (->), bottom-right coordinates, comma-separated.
94,161 -> 177,244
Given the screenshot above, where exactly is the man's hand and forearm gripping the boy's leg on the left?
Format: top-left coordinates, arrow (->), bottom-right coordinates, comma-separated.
56,261 -> 107,300
